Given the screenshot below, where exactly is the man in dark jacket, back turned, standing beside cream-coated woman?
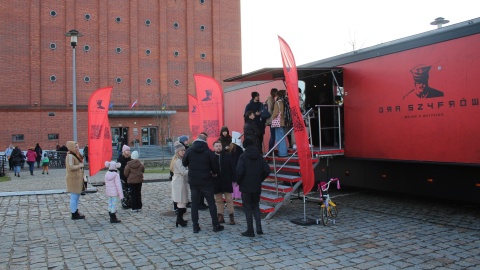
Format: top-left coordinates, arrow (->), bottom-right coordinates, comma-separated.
182,133 -> 223,233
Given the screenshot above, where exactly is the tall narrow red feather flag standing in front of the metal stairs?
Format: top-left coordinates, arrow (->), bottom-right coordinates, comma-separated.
278,36 -> 315,196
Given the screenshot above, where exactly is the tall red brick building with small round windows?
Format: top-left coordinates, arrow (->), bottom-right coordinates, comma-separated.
0,0 -> 241,151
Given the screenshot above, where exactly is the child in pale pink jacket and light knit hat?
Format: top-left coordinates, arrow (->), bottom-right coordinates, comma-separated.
105,160 -> 123,223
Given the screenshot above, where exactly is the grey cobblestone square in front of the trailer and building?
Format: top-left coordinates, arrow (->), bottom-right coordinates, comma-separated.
0,169 -> 480,270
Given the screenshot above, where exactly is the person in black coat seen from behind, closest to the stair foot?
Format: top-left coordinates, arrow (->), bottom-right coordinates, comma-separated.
236,139 -> 270,237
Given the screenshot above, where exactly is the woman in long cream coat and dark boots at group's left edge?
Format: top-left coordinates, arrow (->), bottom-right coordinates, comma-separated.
170,141 -> 188,227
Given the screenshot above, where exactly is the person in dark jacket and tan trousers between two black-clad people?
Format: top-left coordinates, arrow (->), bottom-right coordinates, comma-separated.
213,141 -> 235,225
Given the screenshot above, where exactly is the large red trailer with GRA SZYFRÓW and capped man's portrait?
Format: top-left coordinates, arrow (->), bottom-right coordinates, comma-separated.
225,18 -> 480,203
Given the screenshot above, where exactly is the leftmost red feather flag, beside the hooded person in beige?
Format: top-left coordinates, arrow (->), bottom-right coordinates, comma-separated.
88,86 -> 113,176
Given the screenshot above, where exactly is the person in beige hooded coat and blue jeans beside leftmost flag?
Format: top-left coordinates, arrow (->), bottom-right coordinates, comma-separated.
65,141 -> 85,220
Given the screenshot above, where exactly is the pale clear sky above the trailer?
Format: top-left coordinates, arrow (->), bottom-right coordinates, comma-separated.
240,0 -> 480,74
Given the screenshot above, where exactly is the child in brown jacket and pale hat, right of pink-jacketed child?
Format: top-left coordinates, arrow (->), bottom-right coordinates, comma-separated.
124,151 -> 145,212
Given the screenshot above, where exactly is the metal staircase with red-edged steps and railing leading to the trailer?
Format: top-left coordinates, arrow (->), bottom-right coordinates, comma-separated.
234,105 -> 344,219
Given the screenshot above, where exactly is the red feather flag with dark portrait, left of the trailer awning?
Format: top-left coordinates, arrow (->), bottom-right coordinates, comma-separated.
193,74 -> 223,147
